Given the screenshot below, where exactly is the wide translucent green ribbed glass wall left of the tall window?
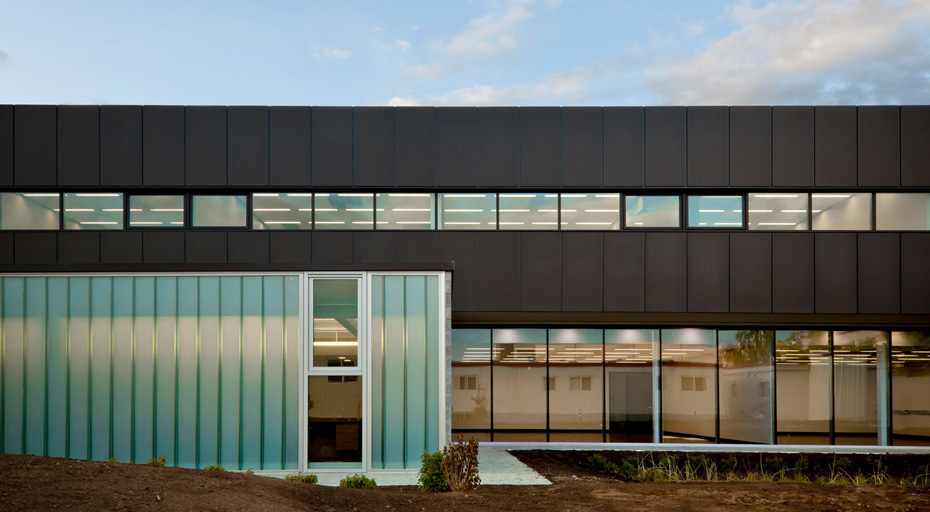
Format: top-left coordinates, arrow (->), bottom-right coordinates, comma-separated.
0,275 -> 299,469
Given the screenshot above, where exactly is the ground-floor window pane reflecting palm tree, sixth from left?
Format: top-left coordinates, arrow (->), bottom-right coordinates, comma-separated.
717,330 -> 775,444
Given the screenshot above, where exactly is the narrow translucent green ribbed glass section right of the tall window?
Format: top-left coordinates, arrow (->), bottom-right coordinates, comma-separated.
371,275 -> 444,469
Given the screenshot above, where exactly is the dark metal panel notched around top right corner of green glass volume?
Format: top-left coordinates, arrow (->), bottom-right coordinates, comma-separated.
437,231 -> 479,311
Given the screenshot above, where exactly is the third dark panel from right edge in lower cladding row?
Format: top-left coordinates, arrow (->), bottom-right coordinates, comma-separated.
814,233 -> 857,313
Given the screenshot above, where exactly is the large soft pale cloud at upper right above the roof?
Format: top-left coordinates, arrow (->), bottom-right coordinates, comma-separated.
647,0 -> 930,105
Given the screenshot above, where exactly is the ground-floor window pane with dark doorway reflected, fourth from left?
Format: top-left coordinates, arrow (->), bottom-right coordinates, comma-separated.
604,329 -> 659,443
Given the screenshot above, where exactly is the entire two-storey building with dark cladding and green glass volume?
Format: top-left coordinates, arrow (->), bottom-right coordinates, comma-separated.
0,105 -> 930,470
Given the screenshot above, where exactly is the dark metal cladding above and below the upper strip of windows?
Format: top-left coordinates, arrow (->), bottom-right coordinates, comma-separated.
0,105 -> 930,325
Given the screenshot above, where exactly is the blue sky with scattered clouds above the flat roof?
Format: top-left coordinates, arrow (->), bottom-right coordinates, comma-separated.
0,0 -> 930,106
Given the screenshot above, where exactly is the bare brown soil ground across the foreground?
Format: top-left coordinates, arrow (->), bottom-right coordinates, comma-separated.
0,455 -> 930,512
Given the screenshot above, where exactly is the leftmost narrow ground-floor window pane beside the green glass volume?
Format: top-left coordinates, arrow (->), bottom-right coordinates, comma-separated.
452,329 -> 491,434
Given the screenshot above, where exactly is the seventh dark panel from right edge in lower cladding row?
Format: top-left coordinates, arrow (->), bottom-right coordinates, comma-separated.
644,233 -> 688,311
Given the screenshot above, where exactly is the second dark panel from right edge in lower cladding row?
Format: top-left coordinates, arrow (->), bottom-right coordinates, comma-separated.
858,233 -> 901,314
